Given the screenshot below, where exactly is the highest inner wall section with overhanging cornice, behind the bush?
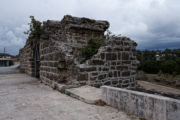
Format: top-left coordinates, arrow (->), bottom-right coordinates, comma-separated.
61,16 -> 109,64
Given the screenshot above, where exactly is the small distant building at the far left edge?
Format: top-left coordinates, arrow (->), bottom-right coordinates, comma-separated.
0,53 -> 12,67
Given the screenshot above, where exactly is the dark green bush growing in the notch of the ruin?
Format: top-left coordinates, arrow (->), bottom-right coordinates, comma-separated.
81,38 -> 105,63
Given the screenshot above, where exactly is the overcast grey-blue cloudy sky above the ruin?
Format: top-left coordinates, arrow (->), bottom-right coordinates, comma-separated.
0,0 -> 180,55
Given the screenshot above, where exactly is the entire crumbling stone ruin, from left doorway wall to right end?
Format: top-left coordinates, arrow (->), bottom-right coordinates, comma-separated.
20,15 -> 137,87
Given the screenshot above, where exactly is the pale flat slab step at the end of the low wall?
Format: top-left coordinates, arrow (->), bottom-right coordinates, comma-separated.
65,85 -> 101,104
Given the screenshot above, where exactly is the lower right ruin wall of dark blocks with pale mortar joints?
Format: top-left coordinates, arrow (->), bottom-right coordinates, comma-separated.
78,37 -> 137,88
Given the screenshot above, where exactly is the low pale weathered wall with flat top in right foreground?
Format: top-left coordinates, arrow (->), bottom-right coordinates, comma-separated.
102,86 -> 180,120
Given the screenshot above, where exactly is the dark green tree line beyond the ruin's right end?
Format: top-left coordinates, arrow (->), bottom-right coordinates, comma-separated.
137,49 -> 180,75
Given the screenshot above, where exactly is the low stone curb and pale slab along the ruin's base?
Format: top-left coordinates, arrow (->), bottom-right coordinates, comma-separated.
42,80 -> 103,104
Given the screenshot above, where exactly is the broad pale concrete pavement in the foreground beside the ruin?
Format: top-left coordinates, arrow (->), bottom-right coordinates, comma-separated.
0,74 -> 137,120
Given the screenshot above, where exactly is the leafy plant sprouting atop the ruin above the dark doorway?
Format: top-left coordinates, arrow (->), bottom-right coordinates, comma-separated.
24,16 -> 42,39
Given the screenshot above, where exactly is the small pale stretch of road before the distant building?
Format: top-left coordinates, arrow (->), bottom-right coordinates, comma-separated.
0,63 -> 19,74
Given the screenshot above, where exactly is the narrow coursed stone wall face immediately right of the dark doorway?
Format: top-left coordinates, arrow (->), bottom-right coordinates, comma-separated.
40,21 -> 63,84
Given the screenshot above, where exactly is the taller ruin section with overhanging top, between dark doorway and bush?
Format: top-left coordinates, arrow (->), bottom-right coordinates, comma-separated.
40,16 -> 109,85
